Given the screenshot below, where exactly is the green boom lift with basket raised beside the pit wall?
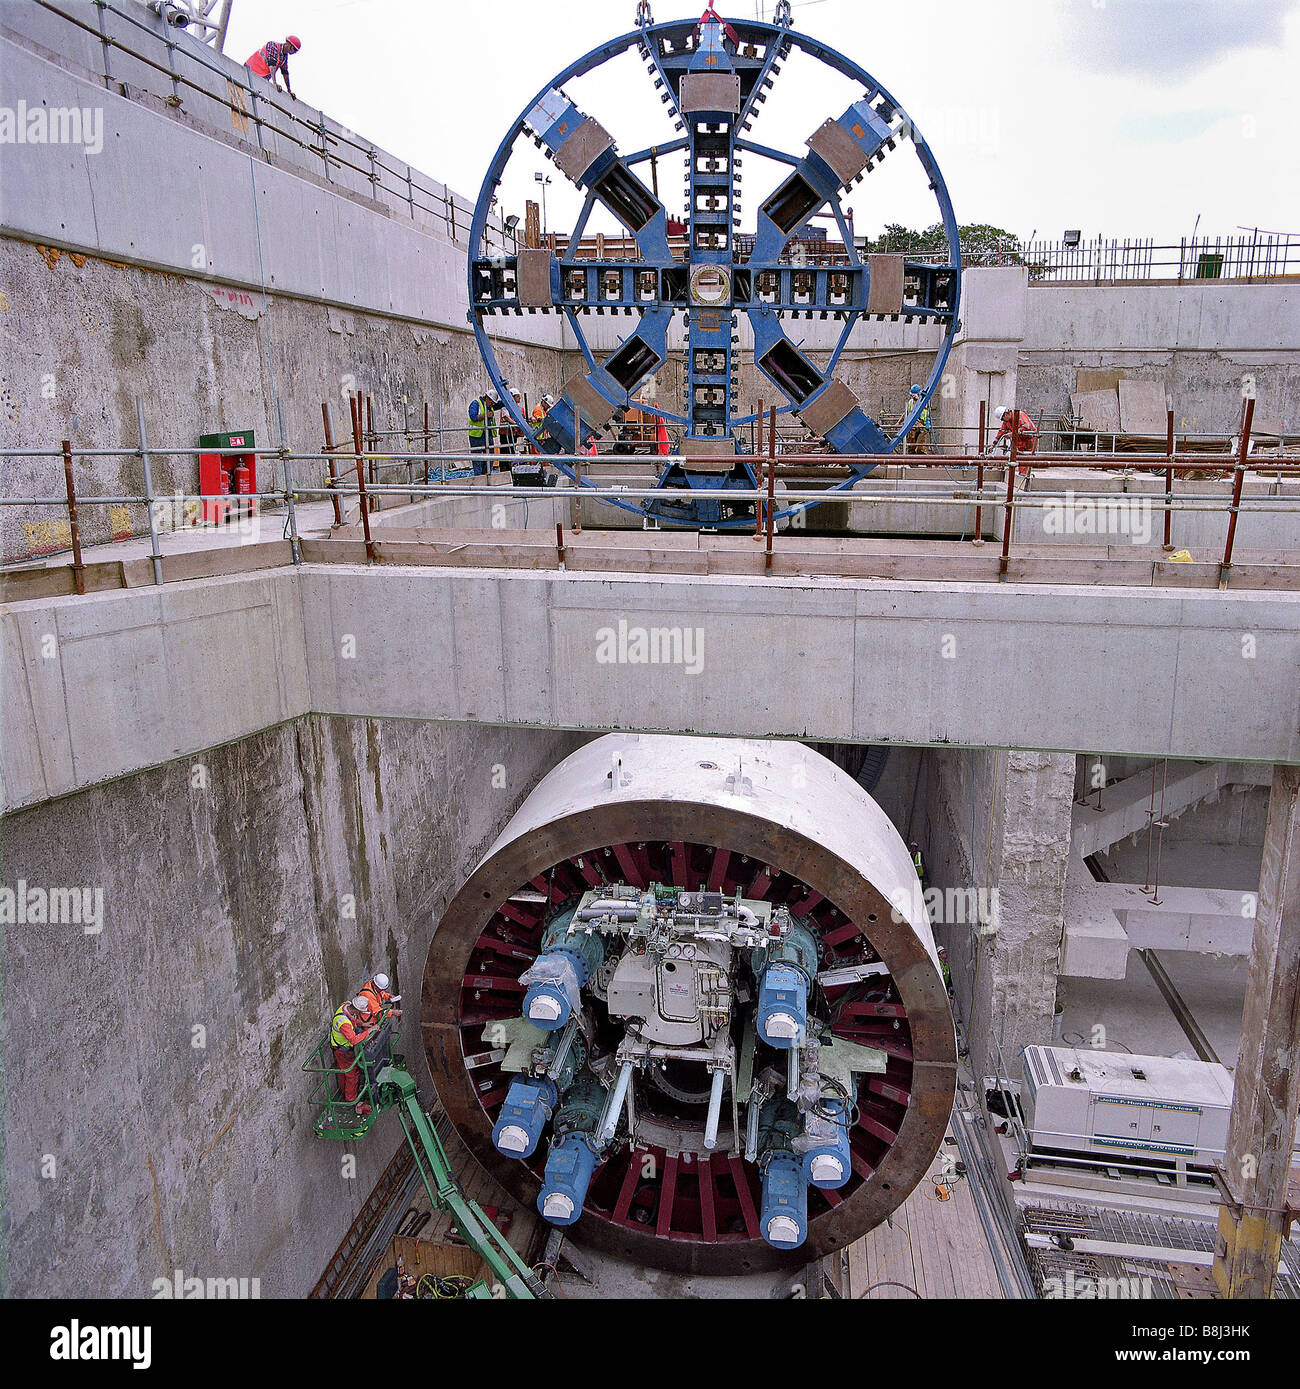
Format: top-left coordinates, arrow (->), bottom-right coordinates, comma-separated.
303,1028 -> 550,1300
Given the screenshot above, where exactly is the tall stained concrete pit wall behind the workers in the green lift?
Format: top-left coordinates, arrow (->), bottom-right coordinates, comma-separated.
0,718 -> 576,1297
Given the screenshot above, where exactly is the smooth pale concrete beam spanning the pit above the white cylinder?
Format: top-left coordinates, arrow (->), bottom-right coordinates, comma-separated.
0,564 -> 1300,807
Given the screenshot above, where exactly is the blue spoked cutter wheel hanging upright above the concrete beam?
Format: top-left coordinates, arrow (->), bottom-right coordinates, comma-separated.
469,4 -> 961,529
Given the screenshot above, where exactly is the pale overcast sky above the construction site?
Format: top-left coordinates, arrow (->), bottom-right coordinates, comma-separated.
226,0 -> 1300,242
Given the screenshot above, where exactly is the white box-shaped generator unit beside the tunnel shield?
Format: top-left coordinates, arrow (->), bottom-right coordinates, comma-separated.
1021,1046 -> 1232,1167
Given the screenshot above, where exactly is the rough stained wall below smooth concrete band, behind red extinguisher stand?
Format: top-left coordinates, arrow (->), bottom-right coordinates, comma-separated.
0,239 -> 565,560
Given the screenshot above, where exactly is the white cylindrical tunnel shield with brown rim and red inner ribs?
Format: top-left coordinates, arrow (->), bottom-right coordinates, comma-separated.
422,735 -> 956,1272
